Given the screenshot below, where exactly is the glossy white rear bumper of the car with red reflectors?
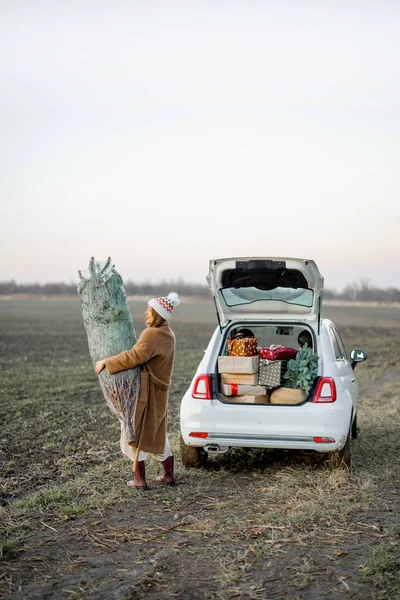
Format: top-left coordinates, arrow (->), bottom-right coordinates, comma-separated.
180,400 -> 352,452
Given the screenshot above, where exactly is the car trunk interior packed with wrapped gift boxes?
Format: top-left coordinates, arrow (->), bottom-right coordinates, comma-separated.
217,322 -> 316,405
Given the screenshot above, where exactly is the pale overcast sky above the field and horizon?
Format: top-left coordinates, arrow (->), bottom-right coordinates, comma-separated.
0,0 -> 400,290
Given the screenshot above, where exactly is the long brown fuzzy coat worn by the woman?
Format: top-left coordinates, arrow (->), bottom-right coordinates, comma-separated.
105,322 -> 175,454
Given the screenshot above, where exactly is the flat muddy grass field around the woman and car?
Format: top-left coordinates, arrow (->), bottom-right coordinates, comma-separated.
0,299 -> 400,600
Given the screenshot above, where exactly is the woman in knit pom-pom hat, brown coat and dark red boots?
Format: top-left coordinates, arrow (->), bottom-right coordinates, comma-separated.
95,292 -> 180,489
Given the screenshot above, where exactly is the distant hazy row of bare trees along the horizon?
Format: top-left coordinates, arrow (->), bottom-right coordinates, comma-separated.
0,279 -> 400,302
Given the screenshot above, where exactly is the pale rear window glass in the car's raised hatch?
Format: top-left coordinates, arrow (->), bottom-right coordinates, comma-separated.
221,287 -> 314,308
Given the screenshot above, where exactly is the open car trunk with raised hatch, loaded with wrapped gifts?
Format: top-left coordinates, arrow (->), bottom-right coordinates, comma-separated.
207,257 -> 324,405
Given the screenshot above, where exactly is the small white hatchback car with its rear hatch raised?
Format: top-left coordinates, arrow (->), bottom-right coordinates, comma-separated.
180,257 -> 367,467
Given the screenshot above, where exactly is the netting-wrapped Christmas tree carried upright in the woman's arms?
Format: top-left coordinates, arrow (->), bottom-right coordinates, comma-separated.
78,257 -> 140,448
